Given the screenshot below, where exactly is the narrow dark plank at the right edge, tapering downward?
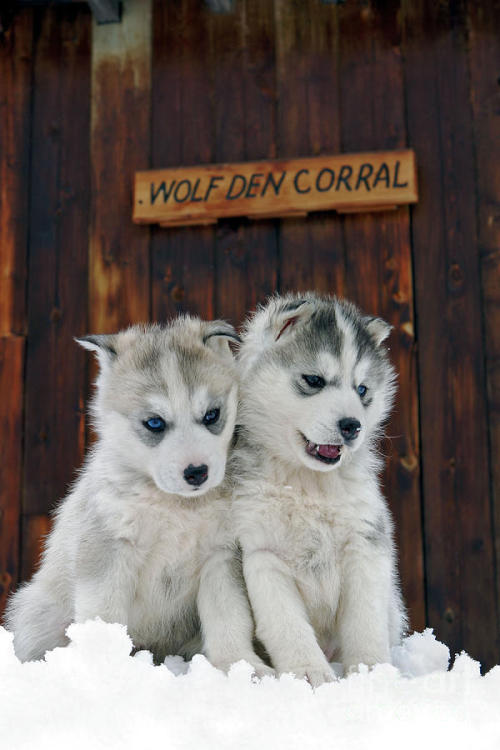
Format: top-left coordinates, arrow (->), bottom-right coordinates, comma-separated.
468,0 -> 500,653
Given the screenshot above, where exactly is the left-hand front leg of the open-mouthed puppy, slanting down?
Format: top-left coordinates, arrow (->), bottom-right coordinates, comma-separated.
243,550 -> 334,686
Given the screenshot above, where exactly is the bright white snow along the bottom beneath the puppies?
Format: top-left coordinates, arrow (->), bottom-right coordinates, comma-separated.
0,620 -> 500,750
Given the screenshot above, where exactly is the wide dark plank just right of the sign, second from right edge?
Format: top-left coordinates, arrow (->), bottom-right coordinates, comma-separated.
403,0 -> 499,667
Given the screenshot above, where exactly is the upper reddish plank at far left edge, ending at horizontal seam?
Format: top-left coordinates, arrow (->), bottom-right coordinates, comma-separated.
0,10 -> 33,336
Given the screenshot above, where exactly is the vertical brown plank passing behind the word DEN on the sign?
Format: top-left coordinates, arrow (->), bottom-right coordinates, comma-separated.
206,1 -> 277,325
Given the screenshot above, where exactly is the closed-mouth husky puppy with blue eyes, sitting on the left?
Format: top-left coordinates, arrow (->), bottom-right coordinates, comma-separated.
6,317 -> 270,674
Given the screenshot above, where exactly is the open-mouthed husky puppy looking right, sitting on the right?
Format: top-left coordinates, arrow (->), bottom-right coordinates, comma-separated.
233,293 -> 406,685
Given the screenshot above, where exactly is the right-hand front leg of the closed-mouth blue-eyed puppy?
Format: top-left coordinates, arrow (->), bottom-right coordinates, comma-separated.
198,548 -> 273,677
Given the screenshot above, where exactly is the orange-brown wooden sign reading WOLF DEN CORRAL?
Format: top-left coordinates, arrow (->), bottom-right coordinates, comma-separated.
133,150 -> 418,226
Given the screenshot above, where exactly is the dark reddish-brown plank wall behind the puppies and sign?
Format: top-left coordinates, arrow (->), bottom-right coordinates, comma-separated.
0,0 -> 500,666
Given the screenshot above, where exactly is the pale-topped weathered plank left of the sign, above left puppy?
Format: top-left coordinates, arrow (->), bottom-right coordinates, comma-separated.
89,0 -> 151,332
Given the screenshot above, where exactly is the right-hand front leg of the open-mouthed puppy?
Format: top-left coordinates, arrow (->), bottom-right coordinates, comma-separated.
337,538 -> 393,672
